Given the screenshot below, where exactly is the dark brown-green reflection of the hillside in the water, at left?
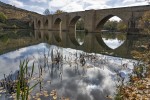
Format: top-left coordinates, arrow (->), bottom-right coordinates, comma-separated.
0,30 -> 38,54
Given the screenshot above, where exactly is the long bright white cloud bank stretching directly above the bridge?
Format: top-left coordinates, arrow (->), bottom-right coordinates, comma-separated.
49,0 -> 147,12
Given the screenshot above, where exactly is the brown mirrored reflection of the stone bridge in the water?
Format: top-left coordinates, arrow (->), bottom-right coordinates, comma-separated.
35,30 -> 137,58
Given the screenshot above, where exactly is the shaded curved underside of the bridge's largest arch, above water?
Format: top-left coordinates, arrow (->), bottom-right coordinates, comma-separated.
95,14 -> 126,31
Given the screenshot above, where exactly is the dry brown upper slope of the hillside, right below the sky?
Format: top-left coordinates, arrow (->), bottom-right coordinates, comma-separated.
0,1 -> 42,19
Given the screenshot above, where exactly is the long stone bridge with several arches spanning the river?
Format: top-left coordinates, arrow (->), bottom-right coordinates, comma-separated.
31,5 -> 150,32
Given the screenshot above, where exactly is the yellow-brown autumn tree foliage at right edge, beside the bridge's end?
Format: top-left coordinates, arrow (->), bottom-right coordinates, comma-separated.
139,11 -> 150,34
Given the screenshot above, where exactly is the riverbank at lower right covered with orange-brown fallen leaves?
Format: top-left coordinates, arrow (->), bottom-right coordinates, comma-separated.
115,44 -> 150,100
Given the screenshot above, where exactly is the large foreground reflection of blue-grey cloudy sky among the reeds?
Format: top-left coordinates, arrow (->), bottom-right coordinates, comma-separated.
0,43 -> 135,100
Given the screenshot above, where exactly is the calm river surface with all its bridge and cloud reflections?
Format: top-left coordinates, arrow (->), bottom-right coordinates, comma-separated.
0,31 -> 149,100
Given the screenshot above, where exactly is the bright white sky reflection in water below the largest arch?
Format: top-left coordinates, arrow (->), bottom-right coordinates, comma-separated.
102,38 -> 124,49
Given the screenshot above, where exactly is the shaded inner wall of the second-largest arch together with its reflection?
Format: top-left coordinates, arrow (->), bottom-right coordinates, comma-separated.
69,16 -> 84,46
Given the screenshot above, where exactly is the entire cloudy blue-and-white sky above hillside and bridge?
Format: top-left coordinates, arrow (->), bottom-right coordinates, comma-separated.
0,0 -> 150,14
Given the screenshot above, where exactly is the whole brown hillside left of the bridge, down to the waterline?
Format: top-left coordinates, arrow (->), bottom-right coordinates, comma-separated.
0,1 -> 42,30
